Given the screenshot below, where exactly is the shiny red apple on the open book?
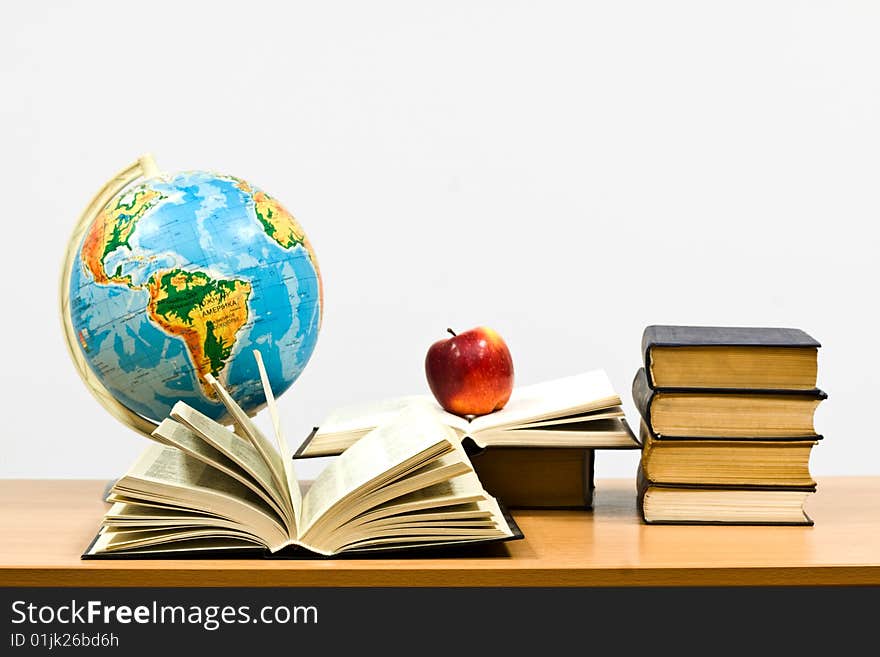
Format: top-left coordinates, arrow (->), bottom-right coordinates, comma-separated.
425,326 -> 513,415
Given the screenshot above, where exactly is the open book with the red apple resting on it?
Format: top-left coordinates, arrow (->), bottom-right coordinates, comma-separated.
295,370 -> 640,458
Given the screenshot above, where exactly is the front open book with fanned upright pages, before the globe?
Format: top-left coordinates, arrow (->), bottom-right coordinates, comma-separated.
83,351 -> 522,558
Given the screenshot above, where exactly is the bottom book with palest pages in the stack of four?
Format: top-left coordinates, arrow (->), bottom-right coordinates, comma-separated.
636,463 -> 816,526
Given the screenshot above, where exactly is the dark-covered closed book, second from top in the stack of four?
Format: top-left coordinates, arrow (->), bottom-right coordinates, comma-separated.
632,367 -> 828,440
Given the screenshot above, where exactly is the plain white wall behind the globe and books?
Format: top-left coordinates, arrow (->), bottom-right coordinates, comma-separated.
0,0 -> 880,478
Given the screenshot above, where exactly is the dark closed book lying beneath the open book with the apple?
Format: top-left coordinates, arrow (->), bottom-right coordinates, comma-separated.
464,439 -> 595,509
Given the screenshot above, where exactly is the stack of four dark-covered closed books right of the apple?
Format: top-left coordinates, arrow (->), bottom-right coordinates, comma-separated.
632,325 -> 827,525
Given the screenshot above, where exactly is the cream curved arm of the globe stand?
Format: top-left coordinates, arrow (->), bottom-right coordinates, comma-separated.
59,154 -> 168,436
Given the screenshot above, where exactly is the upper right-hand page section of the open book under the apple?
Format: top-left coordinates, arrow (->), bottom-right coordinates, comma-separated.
469,370 -> 621,437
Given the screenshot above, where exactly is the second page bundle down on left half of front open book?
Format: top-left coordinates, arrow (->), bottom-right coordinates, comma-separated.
100,443 -> 290,550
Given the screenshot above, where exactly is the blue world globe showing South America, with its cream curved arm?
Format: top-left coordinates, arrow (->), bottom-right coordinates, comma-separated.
61,157 -> 323,432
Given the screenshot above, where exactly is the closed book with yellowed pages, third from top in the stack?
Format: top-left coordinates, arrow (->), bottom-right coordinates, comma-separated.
639,422 -> 817,487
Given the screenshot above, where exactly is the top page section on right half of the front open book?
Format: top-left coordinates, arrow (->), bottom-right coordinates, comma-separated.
300,405 -> 457,538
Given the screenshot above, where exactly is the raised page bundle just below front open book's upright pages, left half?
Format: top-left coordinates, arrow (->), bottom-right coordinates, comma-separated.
152,418 -> 293,526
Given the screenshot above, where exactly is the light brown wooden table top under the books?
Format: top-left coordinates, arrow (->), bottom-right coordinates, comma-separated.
0,477 -> 880,587
